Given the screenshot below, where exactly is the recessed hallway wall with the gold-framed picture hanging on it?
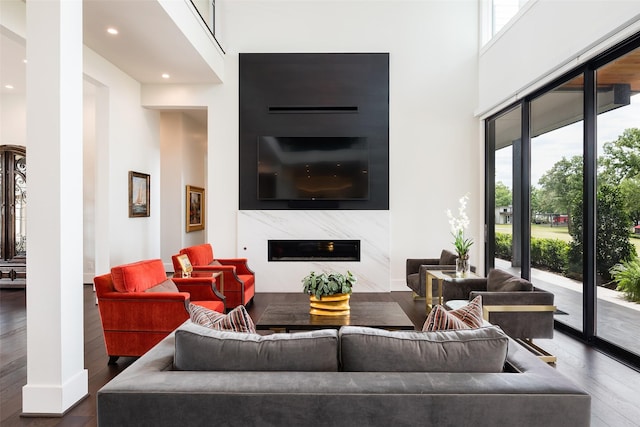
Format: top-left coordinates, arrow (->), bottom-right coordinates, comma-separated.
160,112 -> 207,271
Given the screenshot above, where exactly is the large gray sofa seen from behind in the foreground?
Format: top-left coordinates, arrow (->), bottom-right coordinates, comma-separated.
97,321 -> 590,427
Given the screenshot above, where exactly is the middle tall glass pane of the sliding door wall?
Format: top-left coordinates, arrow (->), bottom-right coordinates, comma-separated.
528,75 -> 584,330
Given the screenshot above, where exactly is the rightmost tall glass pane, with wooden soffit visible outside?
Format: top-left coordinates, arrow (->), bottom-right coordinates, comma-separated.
596,49 -> 640,355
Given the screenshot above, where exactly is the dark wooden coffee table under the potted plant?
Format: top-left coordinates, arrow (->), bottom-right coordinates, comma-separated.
256,301 -> 414,332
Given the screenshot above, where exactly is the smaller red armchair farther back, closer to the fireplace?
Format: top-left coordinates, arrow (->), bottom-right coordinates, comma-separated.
171,243 -> 255,309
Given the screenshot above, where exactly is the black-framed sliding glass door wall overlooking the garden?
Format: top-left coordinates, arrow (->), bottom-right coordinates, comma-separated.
485,34 -> 640,366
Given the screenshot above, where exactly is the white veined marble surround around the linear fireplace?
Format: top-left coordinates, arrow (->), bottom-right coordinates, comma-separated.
237,210 -> 391,292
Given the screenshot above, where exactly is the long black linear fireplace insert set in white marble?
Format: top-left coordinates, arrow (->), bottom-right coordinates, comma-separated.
267,240 -> 360,262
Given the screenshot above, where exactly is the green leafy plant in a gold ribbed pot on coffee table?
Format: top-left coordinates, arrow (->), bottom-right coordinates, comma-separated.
302,271 -> 357,316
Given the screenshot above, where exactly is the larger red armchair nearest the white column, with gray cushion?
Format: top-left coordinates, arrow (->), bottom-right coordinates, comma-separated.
93,259 -> 226,365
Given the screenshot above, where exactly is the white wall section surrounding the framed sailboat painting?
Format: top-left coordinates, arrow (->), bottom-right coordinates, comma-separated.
84,47 -> 161,274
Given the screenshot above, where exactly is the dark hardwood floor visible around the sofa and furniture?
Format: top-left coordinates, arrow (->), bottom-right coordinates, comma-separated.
0,285 -> 640,427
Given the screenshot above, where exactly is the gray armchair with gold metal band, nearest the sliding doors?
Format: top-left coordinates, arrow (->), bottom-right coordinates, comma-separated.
442,269 -> 556,340
